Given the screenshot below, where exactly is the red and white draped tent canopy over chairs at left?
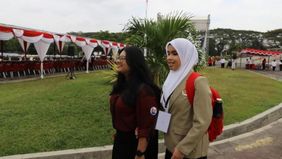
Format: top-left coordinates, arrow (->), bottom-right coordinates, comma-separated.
0,24 -> 125,78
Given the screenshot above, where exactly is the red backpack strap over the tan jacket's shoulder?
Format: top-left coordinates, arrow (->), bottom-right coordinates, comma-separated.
185,72 -> 201,106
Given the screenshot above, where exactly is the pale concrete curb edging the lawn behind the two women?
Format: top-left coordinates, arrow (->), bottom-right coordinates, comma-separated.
0,103 -> 282,159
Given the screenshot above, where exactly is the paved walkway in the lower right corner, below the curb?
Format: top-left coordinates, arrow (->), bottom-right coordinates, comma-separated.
208,118 -> 282,159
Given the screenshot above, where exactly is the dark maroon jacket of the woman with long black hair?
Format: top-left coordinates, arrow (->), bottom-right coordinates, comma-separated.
110,86 -> 158,138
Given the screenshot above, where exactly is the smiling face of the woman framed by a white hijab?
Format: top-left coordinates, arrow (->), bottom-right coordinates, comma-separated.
166,45 -> 181,71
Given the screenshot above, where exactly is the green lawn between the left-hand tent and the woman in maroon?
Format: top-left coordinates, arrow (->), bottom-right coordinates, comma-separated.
0,72 -> 113,156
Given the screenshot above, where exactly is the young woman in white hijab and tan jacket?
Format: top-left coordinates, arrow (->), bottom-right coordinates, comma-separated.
161,38 -> 212,159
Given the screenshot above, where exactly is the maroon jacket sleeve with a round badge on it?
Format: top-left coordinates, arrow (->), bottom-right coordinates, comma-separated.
136,85 -> 158,138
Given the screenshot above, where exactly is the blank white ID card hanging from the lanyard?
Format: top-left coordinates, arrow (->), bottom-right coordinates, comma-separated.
156,111 -> 171,133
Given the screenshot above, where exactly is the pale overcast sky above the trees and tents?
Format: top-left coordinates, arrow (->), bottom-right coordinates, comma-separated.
0,0 -> 282,33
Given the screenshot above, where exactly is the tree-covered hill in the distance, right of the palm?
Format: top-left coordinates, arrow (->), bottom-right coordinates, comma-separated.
208,28 -> 282,55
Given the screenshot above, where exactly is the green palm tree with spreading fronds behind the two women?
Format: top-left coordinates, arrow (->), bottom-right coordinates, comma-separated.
124,12 -> 204,86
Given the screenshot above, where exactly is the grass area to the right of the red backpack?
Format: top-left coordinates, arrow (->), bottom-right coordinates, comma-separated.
200,68 -> 282,125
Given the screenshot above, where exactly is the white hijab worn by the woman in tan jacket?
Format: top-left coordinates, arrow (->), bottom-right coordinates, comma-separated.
161,38 -> 198,106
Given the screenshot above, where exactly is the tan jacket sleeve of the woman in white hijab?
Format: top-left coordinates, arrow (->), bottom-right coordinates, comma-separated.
176,77 -> 212,155
